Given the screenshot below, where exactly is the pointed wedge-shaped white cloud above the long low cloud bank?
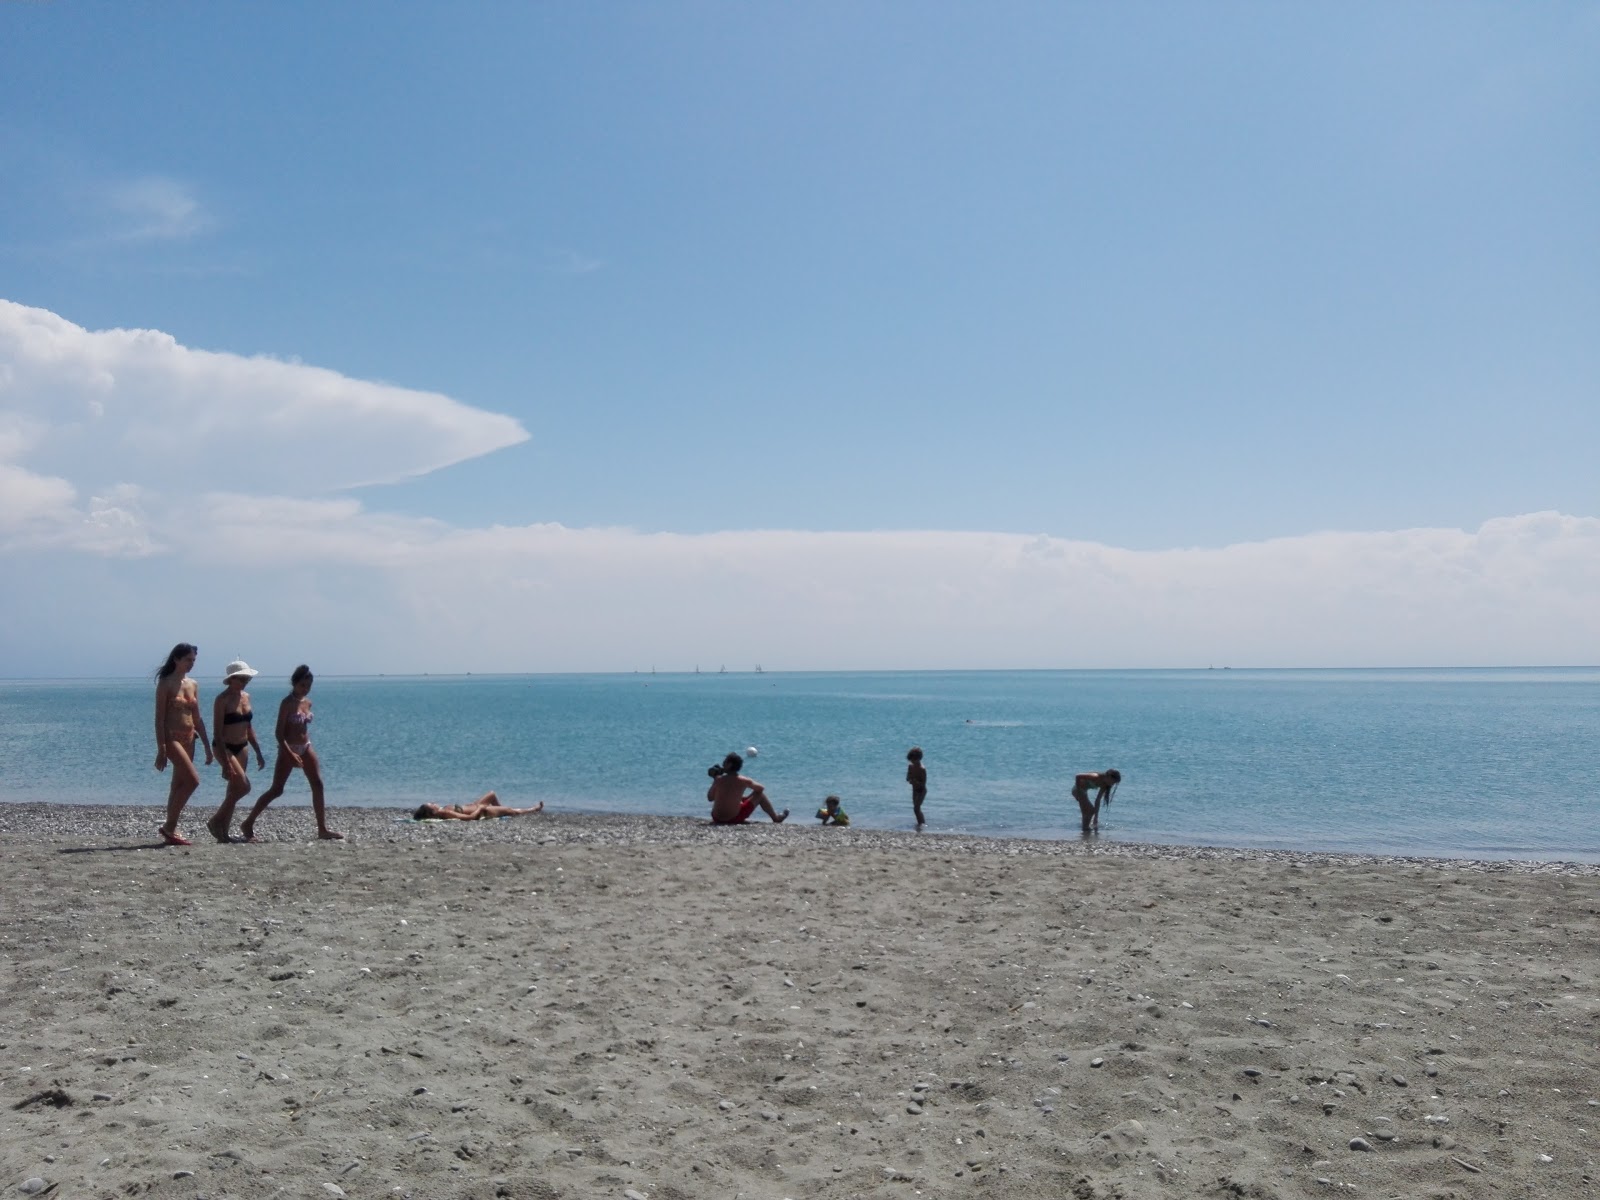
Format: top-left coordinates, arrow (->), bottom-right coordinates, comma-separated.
0,301 -> 528,494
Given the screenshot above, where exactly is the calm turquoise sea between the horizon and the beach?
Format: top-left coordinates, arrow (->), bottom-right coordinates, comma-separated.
0,667 -> 1600,862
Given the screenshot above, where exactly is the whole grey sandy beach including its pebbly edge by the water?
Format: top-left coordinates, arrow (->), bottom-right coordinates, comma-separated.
0,805 -> 1600,1200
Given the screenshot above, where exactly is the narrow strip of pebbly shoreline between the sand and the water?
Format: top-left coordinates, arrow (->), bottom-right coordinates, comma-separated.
0,802 -> 1600,878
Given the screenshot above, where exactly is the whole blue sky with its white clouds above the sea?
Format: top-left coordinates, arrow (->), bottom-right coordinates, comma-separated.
0,0 -> 1600,677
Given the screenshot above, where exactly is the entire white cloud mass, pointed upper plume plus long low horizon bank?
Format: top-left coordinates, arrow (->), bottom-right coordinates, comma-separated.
0,302 -> 1600,674
